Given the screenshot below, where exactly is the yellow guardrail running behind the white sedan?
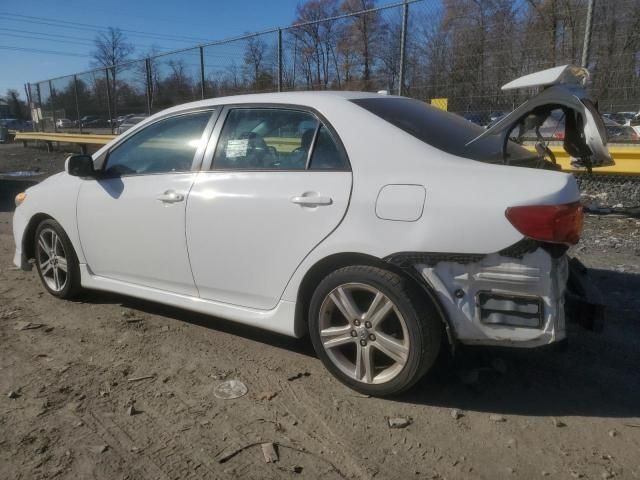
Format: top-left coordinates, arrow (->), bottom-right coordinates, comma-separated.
15,132 -> 640,176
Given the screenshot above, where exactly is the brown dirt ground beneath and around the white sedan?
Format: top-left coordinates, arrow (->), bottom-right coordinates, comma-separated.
0,146 -> 640,480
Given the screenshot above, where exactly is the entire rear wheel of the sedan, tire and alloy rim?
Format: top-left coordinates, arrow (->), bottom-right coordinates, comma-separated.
309,266 -> 442,396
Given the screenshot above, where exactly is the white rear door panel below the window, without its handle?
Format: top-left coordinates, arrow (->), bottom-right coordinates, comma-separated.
187,171 -> 351,309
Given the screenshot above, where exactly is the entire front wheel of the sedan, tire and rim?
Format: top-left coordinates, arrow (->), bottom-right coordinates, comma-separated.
35,219 -> 80,298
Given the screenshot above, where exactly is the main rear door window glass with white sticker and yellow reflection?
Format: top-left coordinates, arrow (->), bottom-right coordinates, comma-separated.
213,108 -> 319,170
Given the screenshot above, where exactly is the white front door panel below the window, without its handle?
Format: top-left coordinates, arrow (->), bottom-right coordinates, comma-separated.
77,172 -> 198,296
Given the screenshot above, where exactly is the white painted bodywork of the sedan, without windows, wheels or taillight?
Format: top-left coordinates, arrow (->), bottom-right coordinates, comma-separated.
14,77 -> 604,346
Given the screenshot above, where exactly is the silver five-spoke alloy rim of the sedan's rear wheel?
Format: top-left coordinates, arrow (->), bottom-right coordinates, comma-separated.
319,283 -> 410,384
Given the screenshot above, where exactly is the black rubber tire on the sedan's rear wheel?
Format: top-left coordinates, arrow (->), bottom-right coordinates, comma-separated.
309,265 -> 442,396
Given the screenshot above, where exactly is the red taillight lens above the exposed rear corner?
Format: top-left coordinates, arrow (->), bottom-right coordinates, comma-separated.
505,202 -> 583,245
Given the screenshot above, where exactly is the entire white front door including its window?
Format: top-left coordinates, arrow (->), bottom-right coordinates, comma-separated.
77,110 -> 212,296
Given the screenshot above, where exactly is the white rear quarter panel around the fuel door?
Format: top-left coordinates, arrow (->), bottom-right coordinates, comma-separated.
283,102 -> 579,301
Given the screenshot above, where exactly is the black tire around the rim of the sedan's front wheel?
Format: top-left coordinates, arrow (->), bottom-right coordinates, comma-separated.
34,219 -> 81,299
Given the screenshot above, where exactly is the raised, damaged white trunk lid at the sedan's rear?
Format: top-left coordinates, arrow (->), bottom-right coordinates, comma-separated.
470,65 -> 614,168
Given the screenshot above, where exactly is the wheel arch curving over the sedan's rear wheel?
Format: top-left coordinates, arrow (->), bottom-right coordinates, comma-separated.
294,252 -> 455,351
